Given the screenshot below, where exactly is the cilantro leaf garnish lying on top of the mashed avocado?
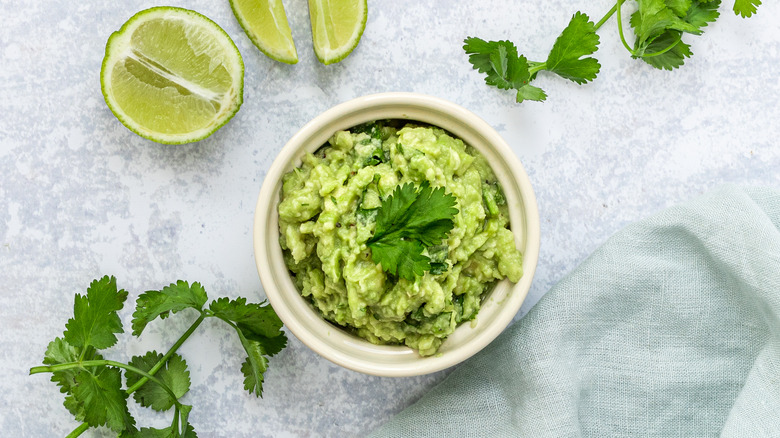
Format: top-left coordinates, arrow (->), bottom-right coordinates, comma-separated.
366,181 -> 458,281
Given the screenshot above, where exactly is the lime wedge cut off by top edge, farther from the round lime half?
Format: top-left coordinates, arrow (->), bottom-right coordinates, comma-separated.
309,0 -> 368,64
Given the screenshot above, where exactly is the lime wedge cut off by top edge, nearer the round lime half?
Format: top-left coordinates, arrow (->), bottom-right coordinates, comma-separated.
230,0 -> 298,64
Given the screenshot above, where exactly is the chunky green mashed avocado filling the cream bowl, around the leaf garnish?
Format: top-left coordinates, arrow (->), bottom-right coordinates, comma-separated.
279,121 -> 522,356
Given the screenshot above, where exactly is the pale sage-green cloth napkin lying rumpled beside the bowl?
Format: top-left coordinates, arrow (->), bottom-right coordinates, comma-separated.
373,186 -> 780,438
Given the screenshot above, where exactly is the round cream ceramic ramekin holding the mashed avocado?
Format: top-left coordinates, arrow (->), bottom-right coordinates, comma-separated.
254,93 -> 540,376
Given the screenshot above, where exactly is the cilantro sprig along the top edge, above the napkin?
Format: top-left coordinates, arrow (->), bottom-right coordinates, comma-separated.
463,0 -> 761,102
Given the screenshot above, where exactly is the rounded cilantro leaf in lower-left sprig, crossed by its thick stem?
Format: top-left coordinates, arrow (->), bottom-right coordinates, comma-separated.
125,351 -> 190,411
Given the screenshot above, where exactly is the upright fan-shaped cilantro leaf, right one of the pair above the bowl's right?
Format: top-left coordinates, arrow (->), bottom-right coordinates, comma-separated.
545,12 -> 601,85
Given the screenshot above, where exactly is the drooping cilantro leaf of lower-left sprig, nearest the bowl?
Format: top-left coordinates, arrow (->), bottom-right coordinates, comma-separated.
209,298 -> 287,397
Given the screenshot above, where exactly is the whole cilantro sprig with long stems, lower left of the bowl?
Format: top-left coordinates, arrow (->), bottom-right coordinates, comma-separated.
30,276 -> 287,438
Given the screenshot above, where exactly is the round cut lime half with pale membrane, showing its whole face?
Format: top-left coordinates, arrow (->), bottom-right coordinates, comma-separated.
100,7 -> 244,144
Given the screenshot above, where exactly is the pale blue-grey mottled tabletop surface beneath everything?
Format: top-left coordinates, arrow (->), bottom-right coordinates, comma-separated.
0,0 -> 780,437
